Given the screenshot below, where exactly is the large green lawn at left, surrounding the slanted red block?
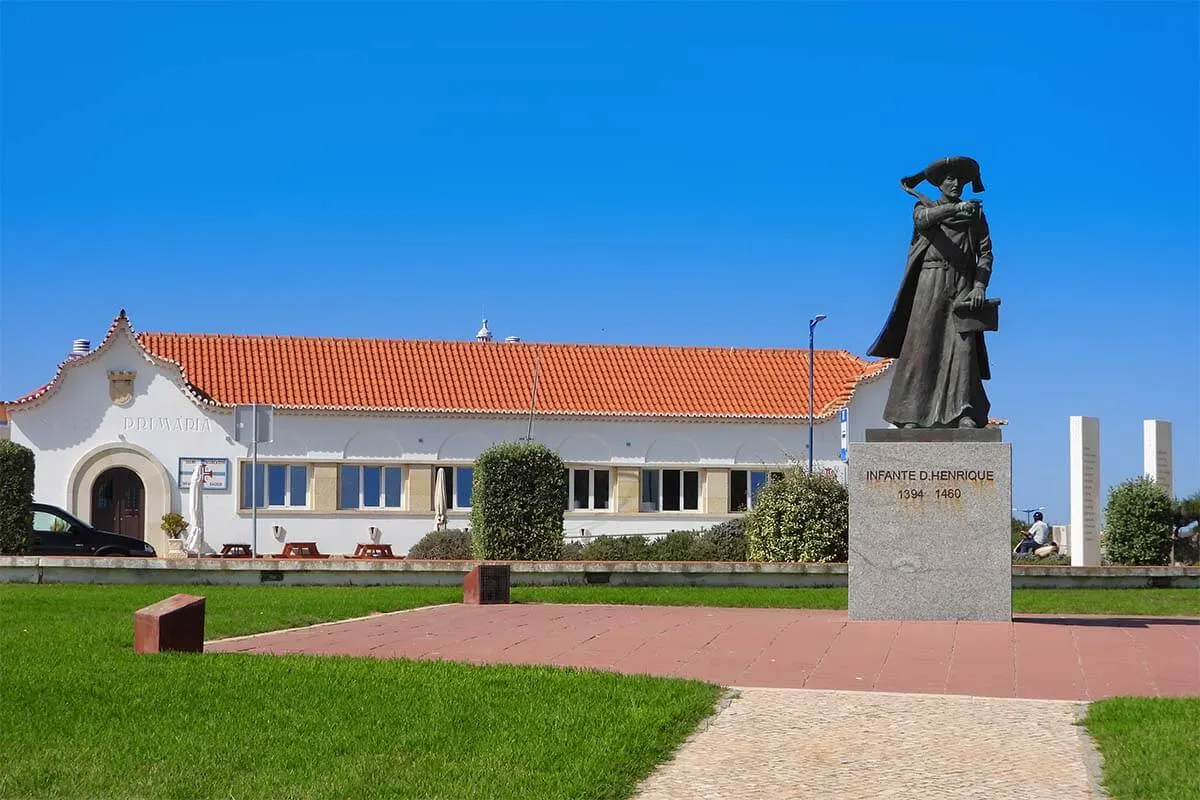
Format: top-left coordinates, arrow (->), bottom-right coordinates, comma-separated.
0,584 -> 720,799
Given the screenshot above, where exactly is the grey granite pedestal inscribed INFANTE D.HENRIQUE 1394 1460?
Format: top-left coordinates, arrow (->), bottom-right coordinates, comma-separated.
847,428 -> 1013,621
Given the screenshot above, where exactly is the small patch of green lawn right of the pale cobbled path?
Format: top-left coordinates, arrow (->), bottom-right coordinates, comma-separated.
1084,697 -> 1200,800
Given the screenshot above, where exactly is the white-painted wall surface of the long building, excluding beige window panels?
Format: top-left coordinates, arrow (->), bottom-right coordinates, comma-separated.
11,333 -> 889,554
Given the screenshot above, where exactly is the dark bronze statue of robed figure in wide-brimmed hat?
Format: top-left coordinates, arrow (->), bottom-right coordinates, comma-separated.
868,156 -> 1000,428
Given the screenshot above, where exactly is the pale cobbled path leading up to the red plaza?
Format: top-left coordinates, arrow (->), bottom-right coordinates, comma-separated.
635,688 -> 1104,800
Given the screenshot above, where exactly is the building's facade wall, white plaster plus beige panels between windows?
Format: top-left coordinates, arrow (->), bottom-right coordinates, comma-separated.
11,335 -> 888,554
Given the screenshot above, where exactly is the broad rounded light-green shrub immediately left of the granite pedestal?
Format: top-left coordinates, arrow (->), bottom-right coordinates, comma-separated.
746,470 -> 850,561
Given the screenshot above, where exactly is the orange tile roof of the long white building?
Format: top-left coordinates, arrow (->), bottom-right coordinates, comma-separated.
7,312 -> 890,419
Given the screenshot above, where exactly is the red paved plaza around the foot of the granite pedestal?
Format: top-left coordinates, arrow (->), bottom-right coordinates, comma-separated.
205,604 -> 1200,700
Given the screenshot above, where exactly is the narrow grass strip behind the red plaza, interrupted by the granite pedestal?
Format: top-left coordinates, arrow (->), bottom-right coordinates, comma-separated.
511,587 -> 1200,616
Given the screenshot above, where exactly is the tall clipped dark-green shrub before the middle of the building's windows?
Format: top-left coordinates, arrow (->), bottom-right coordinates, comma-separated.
470,441 -> 568,561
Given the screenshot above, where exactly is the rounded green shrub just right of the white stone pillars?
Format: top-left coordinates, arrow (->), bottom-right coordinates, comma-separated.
1102,477 -> 1174,566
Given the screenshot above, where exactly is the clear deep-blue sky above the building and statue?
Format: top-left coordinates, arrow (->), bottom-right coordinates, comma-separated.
0,2 -> 1200,522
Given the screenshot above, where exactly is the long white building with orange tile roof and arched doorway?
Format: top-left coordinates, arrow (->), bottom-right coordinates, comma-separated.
7,311 -> 890,554
